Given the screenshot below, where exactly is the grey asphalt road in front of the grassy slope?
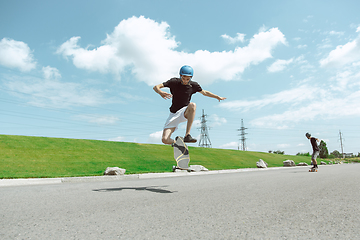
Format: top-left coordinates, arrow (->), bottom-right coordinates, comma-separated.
0,164 -> 360,239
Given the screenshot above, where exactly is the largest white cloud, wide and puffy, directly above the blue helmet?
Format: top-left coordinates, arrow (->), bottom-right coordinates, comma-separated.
57,16 -> 286,85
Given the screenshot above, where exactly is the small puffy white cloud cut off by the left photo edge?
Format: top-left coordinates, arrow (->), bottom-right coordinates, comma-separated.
0,38 -> 36,72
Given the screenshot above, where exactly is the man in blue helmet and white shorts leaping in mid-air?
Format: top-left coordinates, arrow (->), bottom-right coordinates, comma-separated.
153,65 -> 226,144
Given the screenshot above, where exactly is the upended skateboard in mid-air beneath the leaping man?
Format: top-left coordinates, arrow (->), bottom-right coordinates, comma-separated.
173,136 -> 191,172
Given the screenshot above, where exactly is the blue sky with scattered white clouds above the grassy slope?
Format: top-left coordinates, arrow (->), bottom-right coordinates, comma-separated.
0,0 -> 360,154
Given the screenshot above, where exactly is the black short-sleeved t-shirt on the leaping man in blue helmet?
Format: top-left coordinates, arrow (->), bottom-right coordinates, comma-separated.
163,78 -> 202,113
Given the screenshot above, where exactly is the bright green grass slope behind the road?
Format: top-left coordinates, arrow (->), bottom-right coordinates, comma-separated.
0,135 -> 316,178
